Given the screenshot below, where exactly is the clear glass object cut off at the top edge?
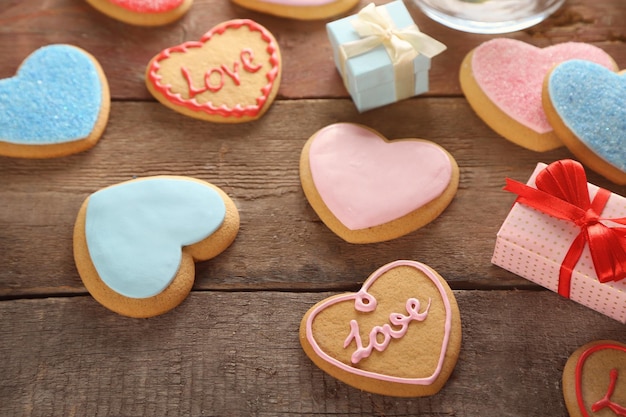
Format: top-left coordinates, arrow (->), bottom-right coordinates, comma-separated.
414,0 -> 565,33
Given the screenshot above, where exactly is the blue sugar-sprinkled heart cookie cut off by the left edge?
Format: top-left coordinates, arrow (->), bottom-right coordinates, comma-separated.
0,44 -> 110,158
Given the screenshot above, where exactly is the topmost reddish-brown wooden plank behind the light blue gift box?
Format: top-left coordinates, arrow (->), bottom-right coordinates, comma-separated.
0,0 -> 626,100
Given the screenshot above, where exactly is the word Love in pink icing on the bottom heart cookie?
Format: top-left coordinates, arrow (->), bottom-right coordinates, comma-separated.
343,298 -> 431,364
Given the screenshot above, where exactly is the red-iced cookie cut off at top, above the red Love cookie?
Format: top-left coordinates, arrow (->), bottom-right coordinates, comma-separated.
87,0 -> 193,26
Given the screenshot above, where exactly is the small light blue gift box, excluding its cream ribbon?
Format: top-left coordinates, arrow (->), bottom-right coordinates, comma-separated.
326,0 -> 438,112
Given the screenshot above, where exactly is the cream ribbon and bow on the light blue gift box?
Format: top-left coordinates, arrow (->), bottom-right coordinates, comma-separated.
339,3 -> 446,100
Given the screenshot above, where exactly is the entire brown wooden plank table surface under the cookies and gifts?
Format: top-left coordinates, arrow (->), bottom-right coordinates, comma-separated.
0,0 -> 626,417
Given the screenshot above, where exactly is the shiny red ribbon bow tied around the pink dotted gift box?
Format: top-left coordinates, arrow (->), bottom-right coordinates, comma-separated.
504,159 -> 626,298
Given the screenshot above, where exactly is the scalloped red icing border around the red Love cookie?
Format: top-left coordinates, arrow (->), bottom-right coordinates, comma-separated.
148,19 -> 280,117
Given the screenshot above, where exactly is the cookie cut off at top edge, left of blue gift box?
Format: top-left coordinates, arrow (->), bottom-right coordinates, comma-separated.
232,0 -> 359,20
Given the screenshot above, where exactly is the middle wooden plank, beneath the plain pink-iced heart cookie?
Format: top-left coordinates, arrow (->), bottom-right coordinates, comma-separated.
0,98 -> 626,297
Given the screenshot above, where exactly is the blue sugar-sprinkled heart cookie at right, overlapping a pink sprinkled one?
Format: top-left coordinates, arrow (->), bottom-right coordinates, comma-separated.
543,60 -> 626,184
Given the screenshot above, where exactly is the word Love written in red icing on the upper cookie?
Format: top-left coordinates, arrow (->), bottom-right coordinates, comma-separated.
180,48 -> 263,98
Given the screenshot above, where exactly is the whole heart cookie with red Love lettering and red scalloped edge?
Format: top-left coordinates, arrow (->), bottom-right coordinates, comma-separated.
146,19 -> 282,123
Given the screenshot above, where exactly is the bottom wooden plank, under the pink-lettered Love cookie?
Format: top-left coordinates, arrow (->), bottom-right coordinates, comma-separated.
0,291 -> 626,417
